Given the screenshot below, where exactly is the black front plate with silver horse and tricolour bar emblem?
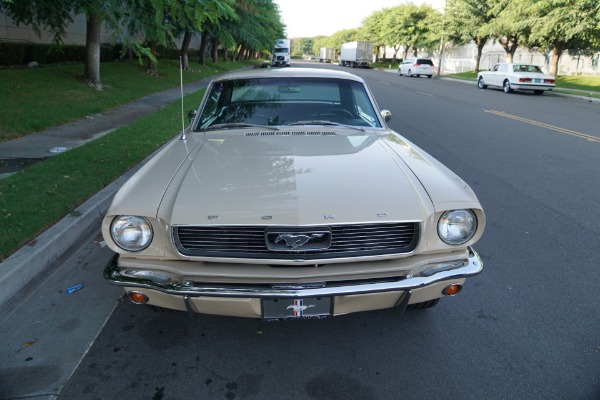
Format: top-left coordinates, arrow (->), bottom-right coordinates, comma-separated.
262,297 -> 332,319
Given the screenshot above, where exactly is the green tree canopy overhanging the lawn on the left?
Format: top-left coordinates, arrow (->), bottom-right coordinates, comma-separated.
0,0 -> 284,84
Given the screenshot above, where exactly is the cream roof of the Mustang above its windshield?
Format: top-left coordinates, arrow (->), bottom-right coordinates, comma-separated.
210,67 -> 364,83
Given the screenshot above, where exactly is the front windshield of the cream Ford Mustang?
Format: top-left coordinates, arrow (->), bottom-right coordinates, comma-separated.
197,78 -> 381,130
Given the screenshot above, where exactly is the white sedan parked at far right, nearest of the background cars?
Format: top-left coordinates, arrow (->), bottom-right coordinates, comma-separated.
477,63 -> 556,95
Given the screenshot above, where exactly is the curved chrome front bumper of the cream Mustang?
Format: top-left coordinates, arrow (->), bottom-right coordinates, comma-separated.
104,247 -> 483,299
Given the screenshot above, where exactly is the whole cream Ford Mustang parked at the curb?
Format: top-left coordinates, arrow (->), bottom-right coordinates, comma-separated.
102,68 -> 485,319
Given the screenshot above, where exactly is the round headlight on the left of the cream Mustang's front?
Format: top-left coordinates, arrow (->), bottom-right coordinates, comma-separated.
110,215 -> 154,251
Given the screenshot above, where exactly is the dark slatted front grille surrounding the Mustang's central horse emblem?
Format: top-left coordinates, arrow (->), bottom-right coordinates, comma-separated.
173,222 -> 419,260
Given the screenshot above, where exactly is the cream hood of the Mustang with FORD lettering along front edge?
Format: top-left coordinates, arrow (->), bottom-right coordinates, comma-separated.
158,130 -> 432,225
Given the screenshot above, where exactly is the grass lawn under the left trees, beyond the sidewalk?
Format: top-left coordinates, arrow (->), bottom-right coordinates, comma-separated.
0,60 -> 253,142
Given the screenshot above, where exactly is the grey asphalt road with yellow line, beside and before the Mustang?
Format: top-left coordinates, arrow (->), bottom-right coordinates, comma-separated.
52,64 -> 600,400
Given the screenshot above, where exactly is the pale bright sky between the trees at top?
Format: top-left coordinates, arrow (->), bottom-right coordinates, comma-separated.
273,0 -> 444,38
